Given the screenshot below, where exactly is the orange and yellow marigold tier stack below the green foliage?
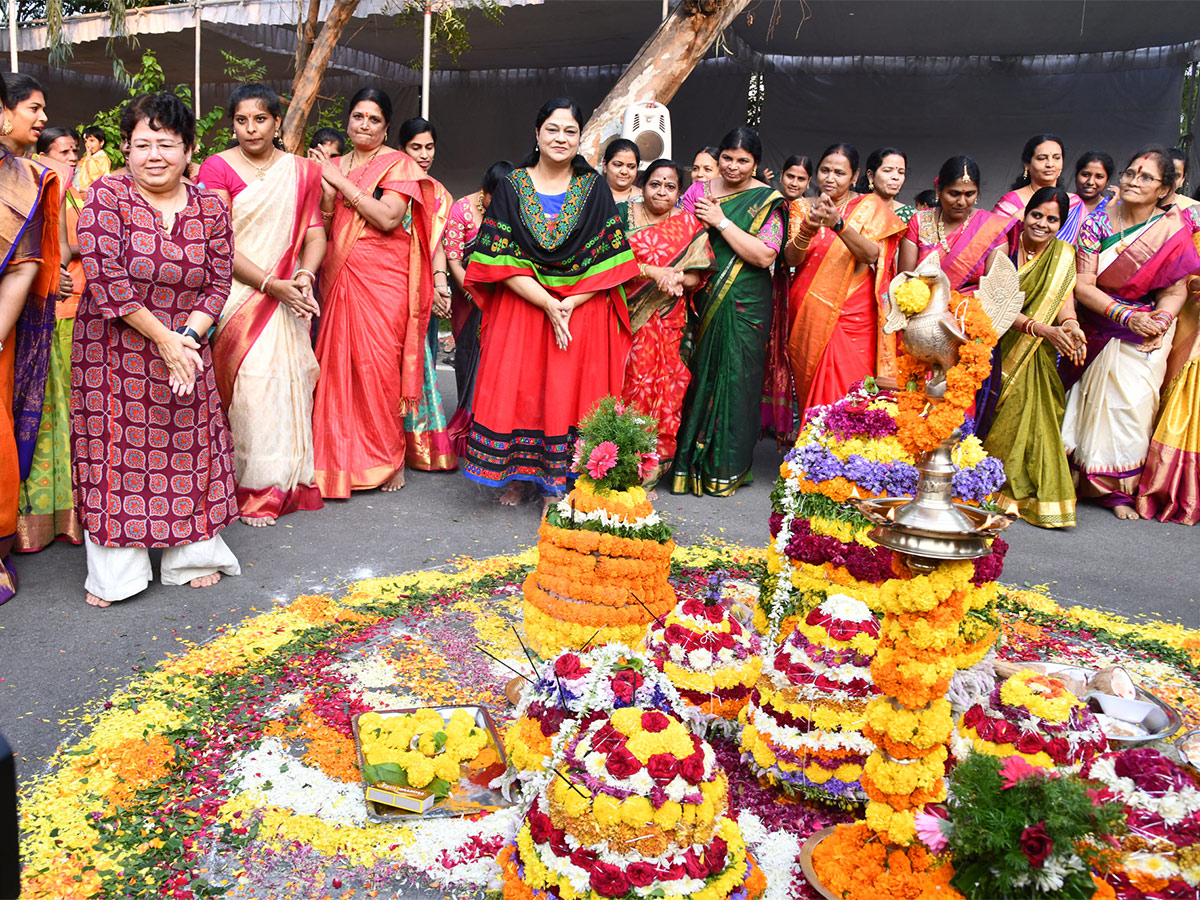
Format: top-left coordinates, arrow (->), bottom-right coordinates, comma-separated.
524,476 -> 676,658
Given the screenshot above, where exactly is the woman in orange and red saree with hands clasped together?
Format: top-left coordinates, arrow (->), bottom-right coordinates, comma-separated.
784,144 -> 904,412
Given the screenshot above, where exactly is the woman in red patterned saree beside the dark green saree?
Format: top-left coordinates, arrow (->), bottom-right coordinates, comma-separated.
617,160 -> 716,484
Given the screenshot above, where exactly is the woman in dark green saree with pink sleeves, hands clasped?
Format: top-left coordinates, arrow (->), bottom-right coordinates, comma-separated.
670,127 -> 787,497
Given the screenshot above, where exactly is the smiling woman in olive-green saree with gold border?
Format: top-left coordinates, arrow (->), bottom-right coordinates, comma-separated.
984,187 -> 1087,528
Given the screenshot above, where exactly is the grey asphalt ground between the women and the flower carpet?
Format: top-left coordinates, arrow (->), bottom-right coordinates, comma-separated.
0,368 -> 1200,779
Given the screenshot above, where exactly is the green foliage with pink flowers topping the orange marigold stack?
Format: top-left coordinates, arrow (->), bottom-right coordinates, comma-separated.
572,396 -> 659,491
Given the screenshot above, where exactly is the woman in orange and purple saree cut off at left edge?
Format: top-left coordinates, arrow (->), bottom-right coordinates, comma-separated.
0,74 -> 60,604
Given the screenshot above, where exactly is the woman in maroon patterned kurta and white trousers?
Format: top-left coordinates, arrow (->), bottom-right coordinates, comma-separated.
71,94 -> 240,606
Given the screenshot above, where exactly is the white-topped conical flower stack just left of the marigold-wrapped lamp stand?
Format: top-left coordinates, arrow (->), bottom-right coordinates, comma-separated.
742,594 -> 880,805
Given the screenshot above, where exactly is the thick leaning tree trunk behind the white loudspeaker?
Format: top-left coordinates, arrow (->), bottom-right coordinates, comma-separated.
580,0 -> 750,166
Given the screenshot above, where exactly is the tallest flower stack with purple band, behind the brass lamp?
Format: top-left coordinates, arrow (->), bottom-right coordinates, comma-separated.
755,382 -> 1008,668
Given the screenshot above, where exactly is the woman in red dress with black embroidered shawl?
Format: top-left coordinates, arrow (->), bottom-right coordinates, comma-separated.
463,98 -> 637,506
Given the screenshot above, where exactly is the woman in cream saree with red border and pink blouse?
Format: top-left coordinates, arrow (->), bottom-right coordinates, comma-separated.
197,84 -> 325,526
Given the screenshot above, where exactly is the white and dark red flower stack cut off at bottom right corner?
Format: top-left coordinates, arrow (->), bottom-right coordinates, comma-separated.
1084,748 -> 1200,900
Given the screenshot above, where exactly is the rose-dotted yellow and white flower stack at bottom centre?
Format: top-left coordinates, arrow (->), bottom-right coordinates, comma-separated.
498,708 -> 766,900
